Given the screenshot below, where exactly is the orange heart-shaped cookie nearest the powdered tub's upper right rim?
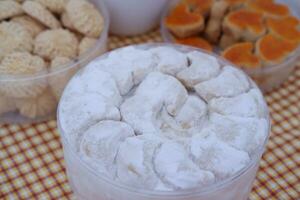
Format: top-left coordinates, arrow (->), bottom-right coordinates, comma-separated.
222,42 -> 260,68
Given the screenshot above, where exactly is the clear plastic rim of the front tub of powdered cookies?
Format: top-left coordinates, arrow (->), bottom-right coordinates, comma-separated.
57,43 -> 271,197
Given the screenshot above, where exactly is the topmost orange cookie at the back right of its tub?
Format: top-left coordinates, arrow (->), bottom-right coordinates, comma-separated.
247,0 -> 290,17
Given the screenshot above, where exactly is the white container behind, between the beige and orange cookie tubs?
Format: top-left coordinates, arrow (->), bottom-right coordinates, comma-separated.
102,0 -> 168,36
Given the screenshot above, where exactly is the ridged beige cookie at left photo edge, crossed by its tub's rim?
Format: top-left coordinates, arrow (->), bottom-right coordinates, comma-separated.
0,52 -> 47,98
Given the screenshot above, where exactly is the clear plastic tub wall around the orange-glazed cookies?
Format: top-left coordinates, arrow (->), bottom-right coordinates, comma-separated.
161,0 -> 300,92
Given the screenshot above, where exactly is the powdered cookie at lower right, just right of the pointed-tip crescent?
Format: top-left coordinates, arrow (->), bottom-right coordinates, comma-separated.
190,135 -> 250,179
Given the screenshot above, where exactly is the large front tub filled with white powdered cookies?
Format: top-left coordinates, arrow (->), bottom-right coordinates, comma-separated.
58,44 -> 270,200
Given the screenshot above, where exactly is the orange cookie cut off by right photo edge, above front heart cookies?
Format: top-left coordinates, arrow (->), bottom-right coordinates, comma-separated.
267,16 -> 300,43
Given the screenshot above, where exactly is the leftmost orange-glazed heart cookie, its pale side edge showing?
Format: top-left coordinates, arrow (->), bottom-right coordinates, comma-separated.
165,4 -> 204,38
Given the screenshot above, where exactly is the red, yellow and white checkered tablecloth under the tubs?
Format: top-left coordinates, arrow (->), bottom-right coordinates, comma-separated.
0,31 -> 300,200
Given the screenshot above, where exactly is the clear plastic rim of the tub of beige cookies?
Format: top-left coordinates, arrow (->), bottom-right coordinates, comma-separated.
0,0 -> 110,83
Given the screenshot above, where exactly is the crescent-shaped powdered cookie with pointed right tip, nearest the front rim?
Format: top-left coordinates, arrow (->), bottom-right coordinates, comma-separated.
154,141 -> 215,190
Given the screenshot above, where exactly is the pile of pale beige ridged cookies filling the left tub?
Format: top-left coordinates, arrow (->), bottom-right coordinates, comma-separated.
0,0 -> 104,118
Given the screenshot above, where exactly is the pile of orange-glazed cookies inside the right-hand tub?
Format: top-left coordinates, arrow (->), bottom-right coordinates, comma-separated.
164,0 -> 300,69
